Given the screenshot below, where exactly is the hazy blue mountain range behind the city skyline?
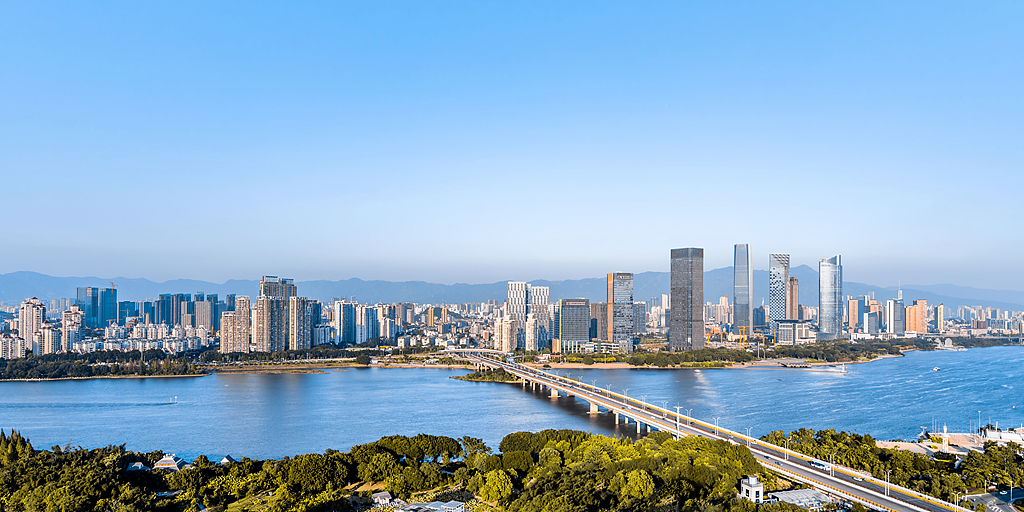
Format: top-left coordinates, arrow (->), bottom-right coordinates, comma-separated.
0,265 -> 1024,310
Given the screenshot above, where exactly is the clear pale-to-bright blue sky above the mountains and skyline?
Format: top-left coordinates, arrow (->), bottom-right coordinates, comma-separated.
0,0 -> 1024,289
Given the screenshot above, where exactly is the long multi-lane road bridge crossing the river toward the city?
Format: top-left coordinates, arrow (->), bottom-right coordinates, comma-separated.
446,348 -> 969,512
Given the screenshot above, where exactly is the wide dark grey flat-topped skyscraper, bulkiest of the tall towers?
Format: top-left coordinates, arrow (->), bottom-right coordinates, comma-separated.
669,248 -> 707,350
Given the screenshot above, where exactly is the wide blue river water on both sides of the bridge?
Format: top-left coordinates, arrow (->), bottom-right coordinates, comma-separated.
0,346 -> 1024,458
